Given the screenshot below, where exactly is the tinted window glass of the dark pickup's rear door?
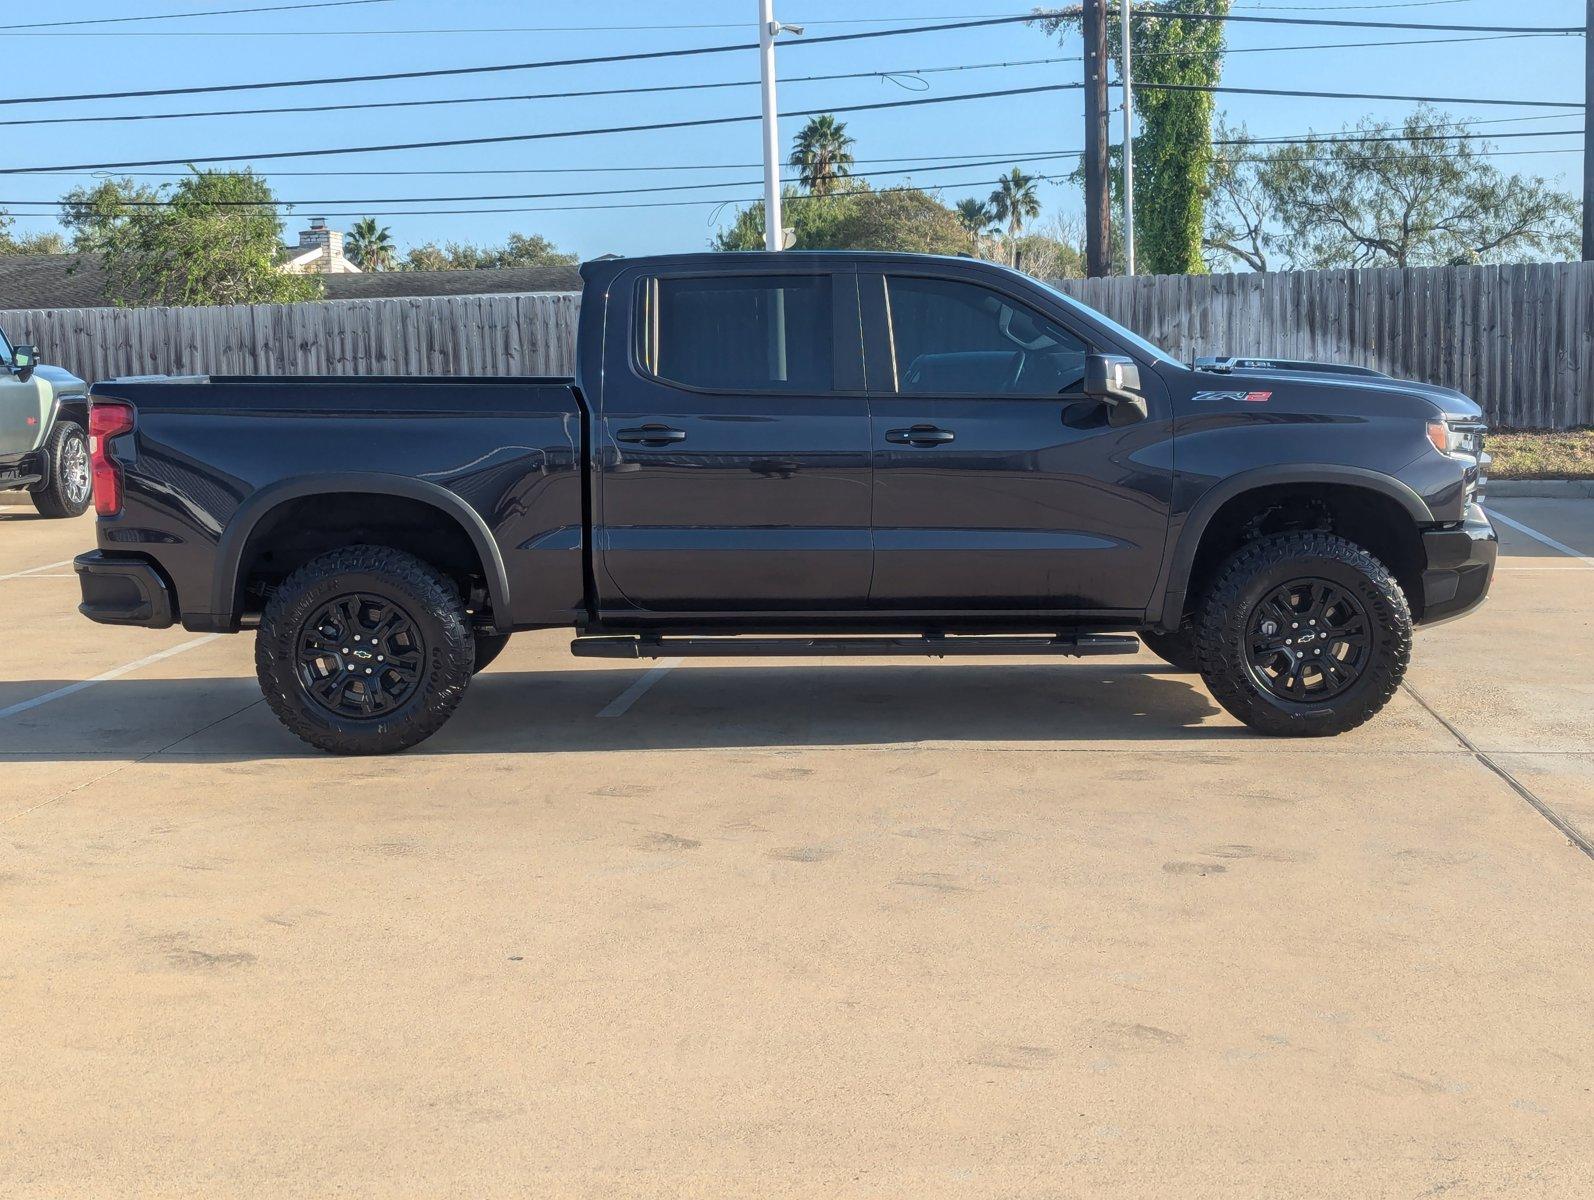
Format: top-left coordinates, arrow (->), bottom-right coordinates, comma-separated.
638,276 -> 834,392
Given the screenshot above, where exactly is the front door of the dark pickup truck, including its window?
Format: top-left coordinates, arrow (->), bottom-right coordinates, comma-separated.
859,271 -> 1172,612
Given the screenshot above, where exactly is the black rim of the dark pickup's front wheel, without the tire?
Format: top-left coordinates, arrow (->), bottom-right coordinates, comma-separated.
1245,578 -> 1372,704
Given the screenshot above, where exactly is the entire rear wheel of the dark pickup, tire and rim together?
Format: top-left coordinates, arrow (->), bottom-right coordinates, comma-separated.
255,545 -> 475,754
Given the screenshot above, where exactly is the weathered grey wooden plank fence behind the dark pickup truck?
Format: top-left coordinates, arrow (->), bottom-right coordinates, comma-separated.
0,263 -> 1594,429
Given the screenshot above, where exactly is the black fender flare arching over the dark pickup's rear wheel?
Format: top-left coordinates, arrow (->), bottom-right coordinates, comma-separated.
210,472 -> 510,628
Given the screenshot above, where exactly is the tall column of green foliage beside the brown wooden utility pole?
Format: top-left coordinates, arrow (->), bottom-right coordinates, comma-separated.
1036,0 -> 1231,274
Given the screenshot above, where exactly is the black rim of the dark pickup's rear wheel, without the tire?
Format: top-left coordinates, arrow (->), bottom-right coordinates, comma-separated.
296,593 -> 426,720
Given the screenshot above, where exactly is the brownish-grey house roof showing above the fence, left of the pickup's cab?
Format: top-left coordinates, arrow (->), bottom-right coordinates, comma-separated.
0,253 -> 582,309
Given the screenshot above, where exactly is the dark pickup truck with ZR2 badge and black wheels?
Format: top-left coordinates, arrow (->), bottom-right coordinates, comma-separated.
77,252 -> 1495,754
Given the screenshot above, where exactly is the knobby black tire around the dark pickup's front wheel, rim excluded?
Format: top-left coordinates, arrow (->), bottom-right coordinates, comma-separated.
1196,532 -> 1411,738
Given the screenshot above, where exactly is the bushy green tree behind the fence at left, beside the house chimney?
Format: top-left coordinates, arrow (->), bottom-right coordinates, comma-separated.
61,171 -> 322,304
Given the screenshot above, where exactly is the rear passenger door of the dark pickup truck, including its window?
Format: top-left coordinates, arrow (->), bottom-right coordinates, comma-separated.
595,260 -> 872,614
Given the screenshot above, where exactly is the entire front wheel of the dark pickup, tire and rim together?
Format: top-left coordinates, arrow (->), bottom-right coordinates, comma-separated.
1197,532 -> 1411,738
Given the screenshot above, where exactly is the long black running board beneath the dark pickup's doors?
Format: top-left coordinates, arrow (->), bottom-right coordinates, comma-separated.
571,634 -> 1140,658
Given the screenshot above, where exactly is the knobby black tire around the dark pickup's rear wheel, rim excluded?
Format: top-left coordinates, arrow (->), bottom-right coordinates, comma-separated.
255,545 -> 477,754
